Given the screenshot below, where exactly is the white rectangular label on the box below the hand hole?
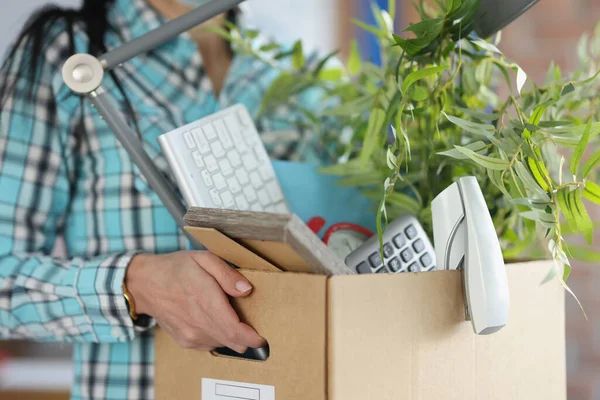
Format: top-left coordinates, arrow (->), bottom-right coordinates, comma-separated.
202,378 -> 275,400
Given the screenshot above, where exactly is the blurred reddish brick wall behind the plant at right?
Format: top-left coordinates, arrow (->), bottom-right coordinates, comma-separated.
399,0 -> 600,400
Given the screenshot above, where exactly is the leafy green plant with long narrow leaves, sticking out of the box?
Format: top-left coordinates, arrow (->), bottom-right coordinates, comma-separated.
211,0 -> 600,286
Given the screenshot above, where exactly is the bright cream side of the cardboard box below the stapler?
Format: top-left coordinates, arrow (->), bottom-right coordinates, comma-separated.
328,262 -> 566,400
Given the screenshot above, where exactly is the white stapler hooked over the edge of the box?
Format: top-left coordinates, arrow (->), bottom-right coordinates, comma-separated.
431,176 -> 509,335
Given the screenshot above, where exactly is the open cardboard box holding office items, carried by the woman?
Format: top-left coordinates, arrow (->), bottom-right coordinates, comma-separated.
155,262 -> 566,400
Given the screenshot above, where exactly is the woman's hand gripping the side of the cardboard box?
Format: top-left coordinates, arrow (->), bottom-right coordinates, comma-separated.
126,251 -> 266,353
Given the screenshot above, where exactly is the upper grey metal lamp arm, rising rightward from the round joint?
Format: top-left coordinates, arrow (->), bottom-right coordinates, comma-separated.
98,0 -> 244,70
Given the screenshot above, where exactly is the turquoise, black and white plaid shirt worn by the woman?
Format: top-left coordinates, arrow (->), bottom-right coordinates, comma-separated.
0,0 -> 328,400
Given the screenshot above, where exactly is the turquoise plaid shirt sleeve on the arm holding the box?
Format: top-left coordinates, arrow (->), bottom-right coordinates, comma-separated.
0,31 -> 150,343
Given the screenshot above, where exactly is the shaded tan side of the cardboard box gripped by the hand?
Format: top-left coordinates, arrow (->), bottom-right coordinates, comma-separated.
155,270 -> 327,400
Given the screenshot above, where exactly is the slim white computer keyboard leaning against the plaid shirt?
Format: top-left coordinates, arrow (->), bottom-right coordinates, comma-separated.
158,105 -> 289,213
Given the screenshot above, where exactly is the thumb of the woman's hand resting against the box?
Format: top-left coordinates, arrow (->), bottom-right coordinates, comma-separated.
194,251 -> 252,297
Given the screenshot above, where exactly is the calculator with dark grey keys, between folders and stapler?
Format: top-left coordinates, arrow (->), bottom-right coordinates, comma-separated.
345,215 -> 435,274
